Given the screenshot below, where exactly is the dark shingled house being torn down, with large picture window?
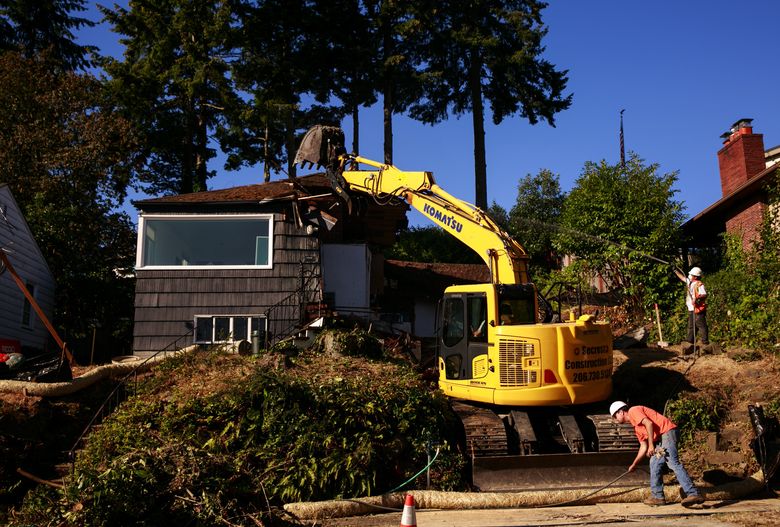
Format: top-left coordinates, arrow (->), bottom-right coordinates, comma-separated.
133,174 -> 408,354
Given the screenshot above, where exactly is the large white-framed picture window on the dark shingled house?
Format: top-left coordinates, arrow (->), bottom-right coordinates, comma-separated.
138,215 -> 273,269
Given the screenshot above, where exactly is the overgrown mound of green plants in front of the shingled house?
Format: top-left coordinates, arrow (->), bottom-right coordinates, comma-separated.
13,346 -> 462,525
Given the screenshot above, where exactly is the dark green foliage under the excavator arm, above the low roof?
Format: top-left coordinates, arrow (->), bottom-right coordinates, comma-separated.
385,225 -> 483,263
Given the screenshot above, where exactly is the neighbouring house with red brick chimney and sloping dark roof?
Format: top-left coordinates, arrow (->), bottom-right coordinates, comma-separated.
682,119 -> 780,249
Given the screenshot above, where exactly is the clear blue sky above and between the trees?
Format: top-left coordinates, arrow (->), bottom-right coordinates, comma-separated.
79,0 -> 780,225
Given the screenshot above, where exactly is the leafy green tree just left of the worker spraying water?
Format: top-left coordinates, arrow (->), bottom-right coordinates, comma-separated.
555,153 -> 682,317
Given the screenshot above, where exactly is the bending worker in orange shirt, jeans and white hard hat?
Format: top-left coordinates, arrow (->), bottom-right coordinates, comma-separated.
609,401 -> 704,507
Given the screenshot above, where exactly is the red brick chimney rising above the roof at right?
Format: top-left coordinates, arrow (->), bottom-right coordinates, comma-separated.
718,119 -> 766,197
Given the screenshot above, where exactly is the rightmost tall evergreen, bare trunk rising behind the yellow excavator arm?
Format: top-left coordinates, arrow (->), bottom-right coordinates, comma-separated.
410,0 -> 571,210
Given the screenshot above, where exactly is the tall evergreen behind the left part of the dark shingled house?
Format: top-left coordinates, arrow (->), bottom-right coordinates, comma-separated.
101,0 -> 240,193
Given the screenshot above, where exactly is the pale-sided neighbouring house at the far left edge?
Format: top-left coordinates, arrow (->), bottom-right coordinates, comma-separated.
0,183 -> 55,352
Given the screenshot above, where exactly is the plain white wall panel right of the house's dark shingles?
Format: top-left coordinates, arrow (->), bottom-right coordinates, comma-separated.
322,243 -> 371,314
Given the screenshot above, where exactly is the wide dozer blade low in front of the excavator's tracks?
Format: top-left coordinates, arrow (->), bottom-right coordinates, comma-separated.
472,452 -> 648,492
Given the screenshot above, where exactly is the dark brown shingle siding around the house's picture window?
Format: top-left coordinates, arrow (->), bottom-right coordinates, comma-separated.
133,209 -> 321,353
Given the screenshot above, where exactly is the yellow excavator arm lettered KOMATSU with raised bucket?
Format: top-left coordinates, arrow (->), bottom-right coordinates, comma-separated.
295,126 -> 529,284
